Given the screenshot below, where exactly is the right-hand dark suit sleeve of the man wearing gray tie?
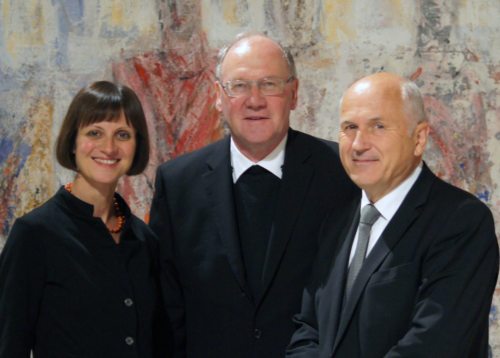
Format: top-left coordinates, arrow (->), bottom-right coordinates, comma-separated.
385,199 -> 498,358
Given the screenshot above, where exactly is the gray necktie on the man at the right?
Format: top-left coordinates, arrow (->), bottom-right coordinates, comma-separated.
345,204 -> 380,297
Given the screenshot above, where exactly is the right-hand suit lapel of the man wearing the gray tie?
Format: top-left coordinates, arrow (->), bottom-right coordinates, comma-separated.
333,164 -> 434,353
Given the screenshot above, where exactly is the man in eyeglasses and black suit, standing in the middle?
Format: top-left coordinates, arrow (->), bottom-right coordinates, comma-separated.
150,34 -> 357,358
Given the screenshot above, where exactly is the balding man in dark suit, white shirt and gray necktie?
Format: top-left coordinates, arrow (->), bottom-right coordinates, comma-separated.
287,73 -> 498,358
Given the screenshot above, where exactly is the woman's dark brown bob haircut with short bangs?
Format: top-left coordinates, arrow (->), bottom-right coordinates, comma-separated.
56,81 -> 149,175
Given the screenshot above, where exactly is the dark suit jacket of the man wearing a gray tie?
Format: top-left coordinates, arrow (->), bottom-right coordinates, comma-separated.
287,164 -> 498,358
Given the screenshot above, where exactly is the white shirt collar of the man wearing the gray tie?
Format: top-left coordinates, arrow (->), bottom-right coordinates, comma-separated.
360,163 -> 422,221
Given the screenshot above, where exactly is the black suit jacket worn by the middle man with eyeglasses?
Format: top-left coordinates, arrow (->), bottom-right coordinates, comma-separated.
150,130 -> 358,358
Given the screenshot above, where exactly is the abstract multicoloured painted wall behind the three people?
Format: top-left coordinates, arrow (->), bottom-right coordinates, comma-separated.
0,0 -> 500,357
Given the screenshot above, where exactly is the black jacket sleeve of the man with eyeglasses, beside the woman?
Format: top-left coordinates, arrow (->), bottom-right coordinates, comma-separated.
149,167 -> 186,357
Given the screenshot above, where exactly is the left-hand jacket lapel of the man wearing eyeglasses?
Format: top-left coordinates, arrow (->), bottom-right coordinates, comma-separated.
203,137 -> 246,290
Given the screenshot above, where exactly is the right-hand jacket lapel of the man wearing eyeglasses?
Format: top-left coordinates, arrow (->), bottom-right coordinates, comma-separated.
260,130 -> 314,299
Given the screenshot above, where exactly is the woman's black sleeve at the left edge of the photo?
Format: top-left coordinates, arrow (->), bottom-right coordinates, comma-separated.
0,218 -> 45,358
